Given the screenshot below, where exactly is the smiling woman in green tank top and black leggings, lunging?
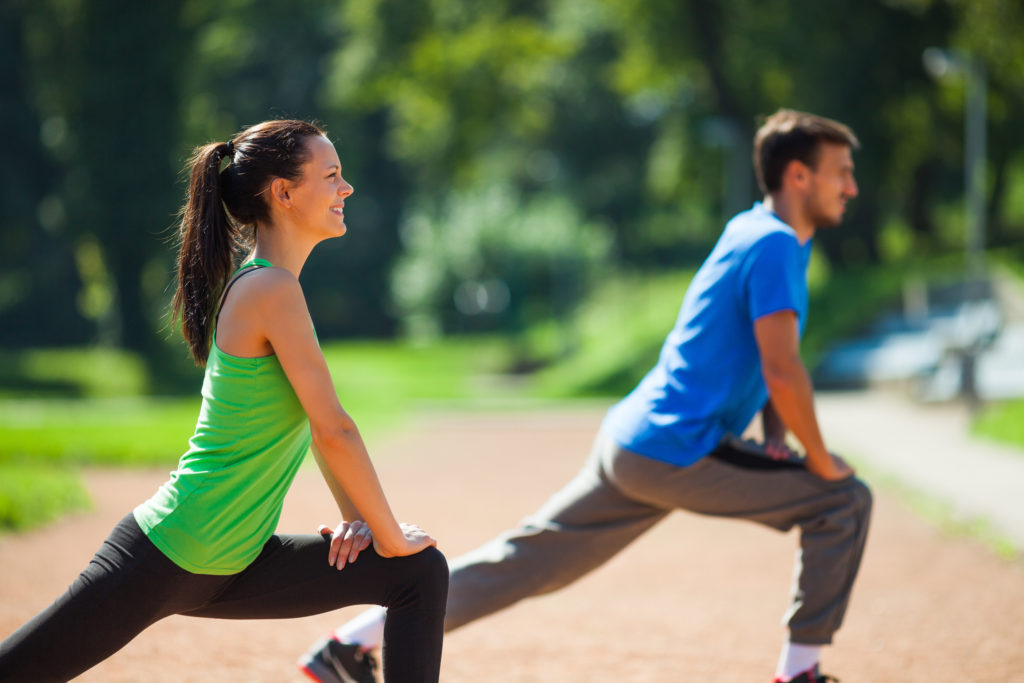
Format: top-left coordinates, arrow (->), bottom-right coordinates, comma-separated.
0,121 -> 447,681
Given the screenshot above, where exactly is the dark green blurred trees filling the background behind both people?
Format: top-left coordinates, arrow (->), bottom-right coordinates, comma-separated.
0,0 -> 1024,401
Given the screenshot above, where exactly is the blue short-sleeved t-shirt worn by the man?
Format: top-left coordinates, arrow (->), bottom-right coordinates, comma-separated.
603,203 -> 811,466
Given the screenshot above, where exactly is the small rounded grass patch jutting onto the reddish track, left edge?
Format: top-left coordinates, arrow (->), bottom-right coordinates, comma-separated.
0,463 -> 89,533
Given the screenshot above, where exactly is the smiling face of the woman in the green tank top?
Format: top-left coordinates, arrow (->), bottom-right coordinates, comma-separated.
289,135 -> 353,240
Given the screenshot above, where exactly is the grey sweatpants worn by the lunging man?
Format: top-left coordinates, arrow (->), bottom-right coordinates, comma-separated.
444,434 -> 871,645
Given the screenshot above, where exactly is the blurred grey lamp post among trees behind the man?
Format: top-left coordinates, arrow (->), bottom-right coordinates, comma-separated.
922,47 -> 987,281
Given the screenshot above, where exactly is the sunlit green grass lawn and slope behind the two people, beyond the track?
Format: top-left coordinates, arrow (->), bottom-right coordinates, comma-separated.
0,252 -> 1003,526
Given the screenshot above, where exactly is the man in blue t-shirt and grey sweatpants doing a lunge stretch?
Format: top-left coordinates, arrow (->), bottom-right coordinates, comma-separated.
300,110 -> 871,683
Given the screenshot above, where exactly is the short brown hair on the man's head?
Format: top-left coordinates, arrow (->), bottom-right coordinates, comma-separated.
754,110 -> 860,195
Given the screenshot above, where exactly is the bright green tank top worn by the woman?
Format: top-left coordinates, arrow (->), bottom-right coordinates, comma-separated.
134,259 -> 311,574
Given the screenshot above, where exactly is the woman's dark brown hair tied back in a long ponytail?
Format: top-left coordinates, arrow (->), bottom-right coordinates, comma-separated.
172,121 -> 324,366
